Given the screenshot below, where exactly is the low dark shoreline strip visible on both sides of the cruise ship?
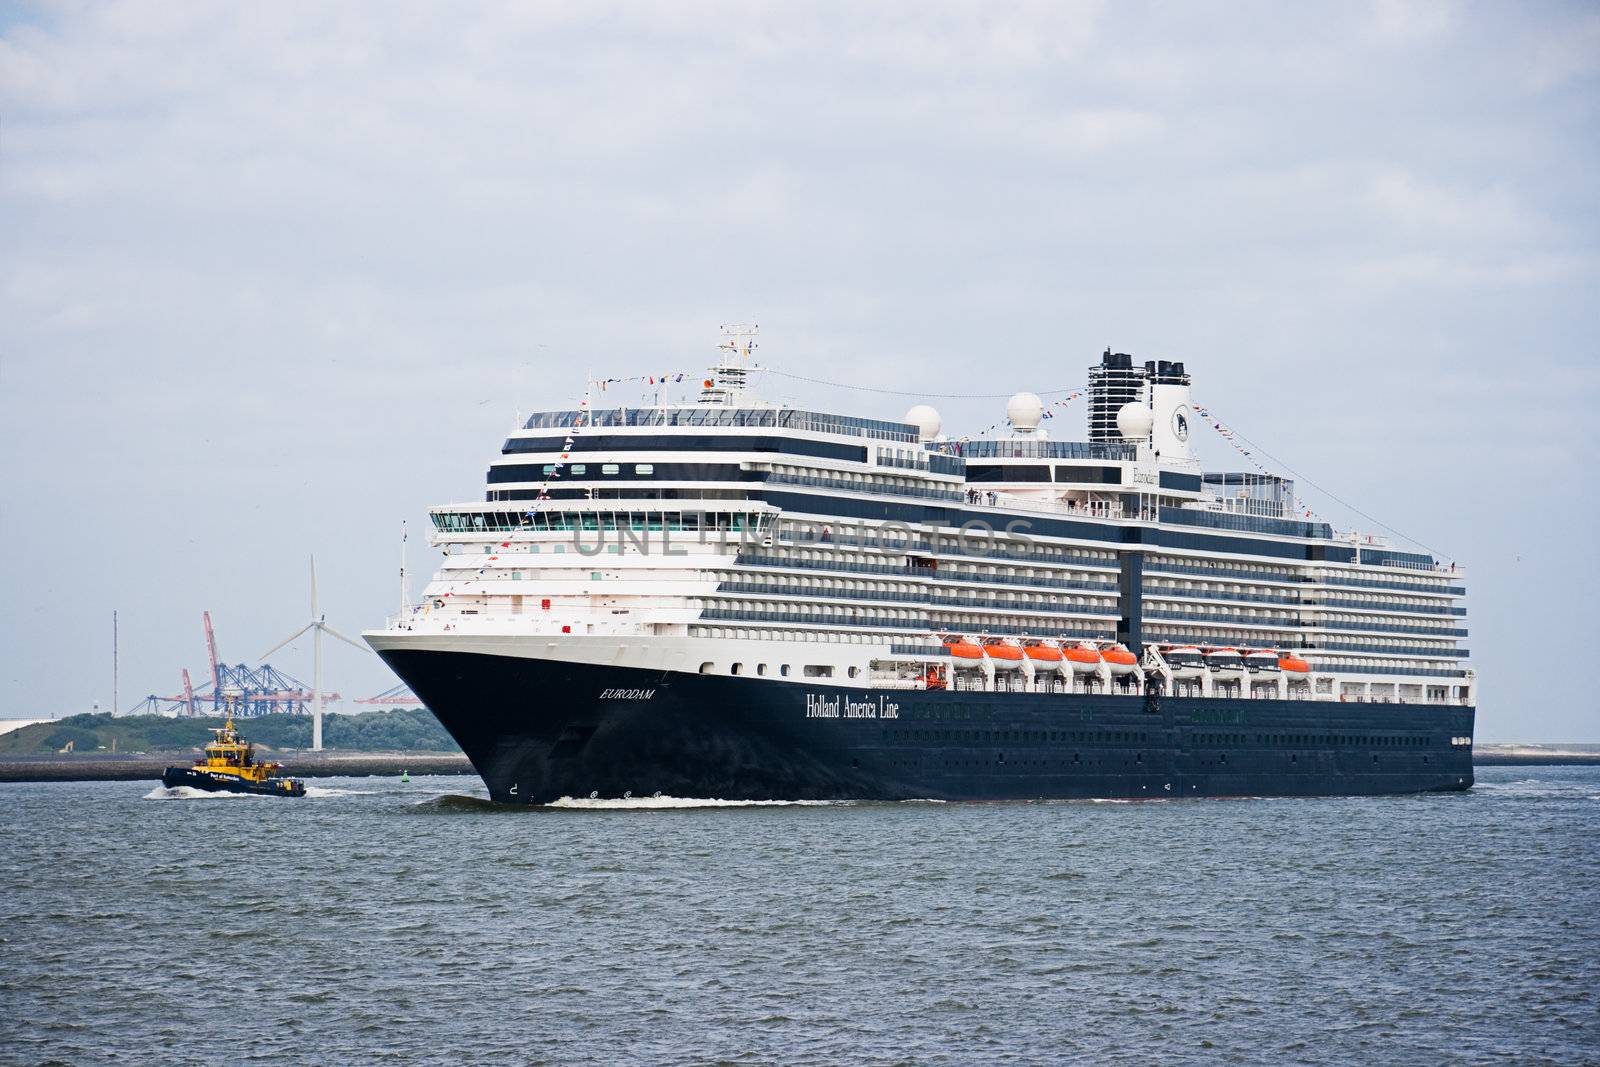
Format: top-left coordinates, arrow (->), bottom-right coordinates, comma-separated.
0,745 -> 1600,784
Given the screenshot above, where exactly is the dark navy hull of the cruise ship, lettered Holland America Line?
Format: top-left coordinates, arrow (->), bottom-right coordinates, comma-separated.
379,649 -> 1474,805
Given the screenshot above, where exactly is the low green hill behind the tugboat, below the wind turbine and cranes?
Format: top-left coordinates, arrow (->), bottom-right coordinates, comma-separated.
0,707 -> 461,755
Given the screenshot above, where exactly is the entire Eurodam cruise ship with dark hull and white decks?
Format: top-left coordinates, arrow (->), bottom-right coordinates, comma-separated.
363,334 -> 1477,805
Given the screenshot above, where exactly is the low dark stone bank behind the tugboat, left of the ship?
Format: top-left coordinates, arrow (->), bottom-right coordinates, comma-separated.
0,750 -> 472,782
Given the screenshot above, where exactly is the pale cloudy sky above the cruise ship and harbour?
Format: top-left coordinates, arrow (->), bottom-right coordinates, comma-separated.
0,0 -> 1600,741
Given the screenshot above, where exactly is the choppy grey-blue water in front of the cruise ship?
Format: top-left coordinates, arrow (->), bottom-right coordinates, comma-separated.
0,768 -> 1600,1064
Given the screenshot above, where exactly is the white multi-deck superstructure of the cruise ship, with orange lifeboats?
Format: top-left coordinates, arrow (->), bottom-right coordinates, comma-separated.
366,342 -> 1475,704
